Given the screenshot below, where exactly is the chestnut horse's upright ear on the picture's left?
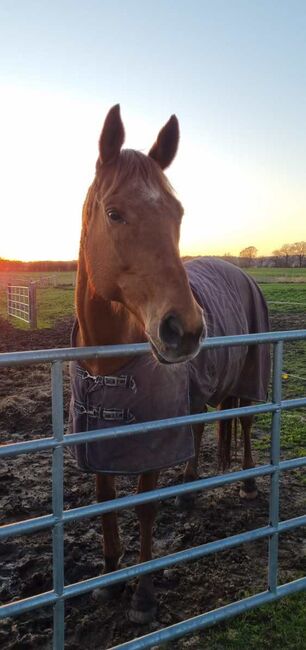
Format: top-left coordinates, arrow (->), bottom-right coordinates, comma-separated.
99,104 -> 124,163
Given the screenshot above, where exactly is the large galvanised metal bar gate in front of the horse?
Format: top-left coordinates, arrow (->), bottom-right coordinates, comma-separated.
0,330 -> 306,650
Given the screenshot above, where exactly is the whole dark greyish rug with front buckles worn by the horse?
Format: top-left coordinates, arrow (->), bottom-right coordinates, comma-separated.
69,257 -> 270,474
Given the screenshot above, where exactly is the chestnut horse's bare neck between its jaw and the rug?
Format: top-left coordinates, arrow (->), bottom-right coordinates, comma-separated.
76,270 -> 146,375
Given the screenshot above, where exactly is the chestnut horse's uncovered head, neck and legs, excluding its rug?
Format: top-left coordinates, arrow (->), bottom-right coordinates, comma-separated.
75,105 -> 270,623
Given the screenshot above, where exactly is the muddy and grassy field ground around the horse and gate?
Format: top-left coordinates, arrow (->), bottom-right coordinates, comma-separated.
0,269 -> 306,650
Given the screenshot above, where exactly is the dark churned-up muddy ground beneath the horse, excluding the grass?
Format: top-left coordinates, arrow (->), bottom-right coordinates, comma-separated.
0,312 -> 306,650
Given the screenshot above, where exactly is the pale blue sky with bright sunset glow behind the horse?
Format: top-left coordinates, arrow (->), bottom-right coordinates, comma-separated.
0,0 -> 306,260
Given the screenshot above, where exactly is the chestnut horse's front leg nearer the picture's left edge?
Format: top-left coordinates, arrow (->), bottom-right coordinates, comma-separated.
94,474 -> 124,600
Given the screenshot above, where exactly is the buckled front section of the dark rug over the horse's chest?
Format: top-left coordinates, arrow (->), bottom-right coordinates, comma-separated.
69,355 -> 194,474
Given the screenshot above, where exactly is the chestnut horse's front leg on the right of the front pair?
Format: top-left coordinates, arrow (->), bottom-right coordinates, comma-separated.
129,471 -> 159,624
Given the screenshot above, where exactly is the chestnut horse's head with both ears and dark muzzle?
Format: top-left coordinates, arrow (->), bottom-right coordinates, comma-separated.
82,106 -> 204,363
